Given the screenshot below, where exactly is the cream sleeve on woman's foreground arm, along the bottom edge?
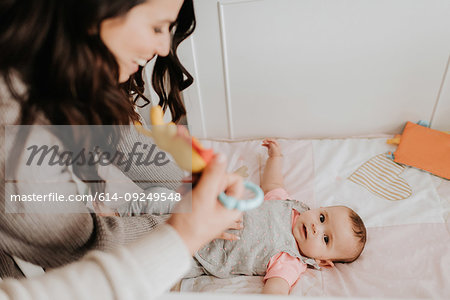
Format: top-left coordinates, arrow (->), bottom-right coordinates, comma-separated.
0,224 -> 190,300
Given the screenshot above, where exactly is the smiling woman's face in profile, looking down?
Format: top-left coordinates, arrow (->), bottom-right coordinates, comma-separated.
100,0 -> 184,82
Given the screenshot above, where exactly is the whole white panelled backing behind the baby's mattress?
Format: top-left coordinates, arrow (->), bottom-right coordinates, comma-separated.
179,0 -> 450,139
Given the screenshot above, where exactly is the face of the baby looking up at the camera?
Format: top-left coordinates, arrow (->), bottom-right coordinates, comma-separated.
293,206 -> 360,265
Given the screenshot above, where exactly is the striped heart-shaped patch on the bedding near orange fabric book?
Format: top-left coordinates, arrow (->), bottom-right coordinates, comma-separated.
348,154 -> 412,201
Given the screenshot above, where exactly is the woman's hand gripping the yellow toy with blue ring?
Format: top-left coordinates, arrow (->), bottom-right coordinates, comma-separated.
167,155 -> 244,254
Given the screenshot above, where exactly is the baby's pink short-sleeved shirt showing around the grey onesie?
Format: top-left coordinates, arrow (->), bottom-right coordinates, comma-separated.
264,188 -> 307,287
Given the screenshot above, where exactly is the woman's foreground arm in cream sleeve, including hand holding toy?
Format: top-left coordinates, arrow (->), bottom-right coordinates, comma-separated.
0,158 -> 243,299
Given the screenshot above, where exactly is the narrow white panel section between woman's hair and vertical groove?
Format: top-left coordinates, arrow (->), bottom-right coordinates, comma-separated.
178,0 -> 229,138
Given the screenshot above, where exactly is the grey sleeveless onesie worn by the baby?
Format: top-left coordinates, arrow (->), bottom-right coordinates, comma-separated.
186,200 -> 319,278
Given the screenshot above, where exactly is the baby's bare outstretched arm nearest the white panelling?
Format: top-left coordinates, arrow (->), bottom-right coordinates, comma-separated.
261,139 -> 284,193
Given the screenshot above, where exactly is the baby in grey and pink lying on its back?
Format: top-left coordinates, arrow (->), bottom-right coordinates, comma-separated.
187,139 -> 366,294
